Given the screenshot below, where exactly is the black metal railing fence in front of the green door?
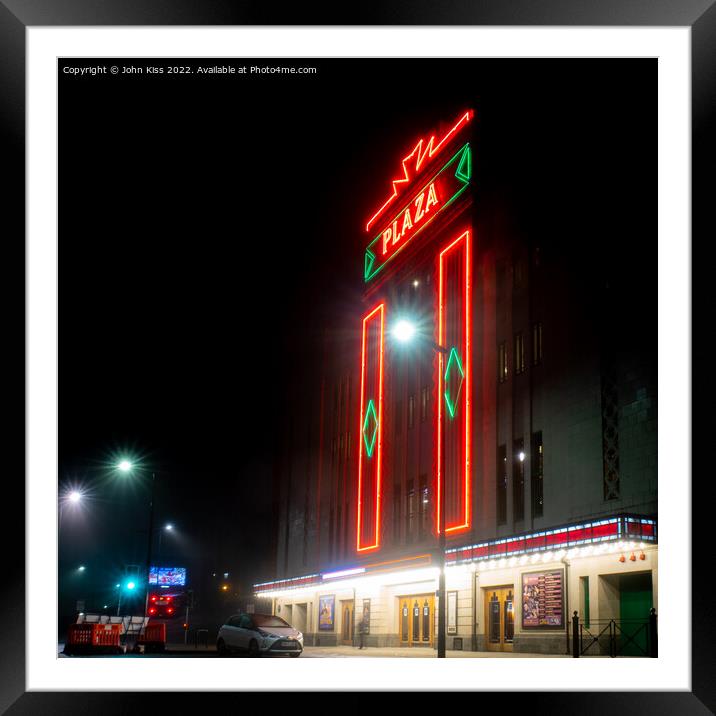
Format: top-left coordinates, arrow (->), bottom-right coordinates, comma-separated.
567,609 -> 659,658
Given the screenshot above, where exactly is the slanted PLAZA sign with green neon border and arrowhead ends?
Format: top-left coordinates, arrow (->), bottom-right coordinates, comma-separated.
363,144 -> 472,281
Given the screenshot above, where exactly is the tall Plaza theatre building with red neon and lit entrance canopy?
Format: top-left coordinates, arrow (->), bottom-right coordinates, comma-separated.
254,107 -> 658,654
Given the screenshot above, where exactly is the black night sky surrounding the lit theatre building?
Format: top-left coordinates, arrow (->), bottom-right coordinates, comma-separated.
58,58 -> 656,612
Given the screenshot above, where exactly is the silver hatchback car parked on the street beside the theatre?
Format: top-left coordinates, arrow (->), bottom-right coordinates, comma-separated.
216,614 -> 303,657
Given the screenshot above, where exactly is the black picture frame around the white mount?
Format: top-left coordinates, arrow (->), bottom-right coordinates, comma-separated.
0,0 -> 704,715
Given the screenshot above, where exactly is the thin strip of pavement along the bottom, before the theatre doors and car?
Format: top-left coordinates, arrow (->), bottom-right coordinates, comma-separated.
57,643 -> 570,659
